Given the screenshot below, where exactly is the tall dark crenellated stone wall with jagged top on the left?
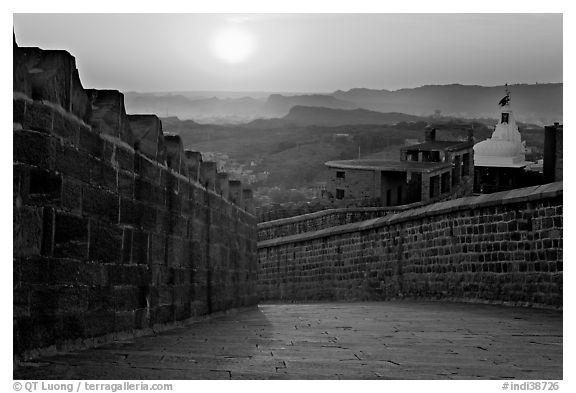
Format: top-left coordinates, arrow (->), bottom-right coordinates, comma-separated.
13,41 -> 257,358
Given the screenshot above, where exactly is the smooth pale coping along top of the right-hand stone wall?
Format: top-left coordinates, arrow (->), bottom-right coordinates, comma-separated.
258,181 -> 563,248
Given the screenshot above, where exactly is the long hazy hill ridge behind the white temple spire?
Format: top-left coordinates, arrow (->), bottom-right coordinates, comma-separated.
333,83 -> 563,125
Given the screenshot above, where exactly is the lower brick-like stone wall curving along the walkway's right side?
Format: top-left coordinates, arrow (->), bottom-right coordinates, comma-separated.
258,182 -> 563,307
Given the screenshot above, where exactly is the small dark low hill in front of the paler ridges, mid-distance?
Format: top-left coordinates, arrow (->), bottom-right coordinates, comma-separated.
283,105 -> 423,126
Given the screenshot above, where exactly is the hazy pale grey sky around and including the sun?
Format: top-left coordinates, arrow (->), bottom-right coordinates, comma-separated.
14,14 -> 563,92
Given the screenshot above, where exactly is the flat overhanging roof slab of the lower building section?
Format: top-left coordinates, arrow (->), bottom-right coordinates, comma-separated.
325,160 -> 451,172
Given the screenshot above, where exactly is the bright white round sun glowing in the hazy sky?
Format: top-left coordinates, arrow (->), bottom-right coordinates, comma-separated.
212,27 -> 255,64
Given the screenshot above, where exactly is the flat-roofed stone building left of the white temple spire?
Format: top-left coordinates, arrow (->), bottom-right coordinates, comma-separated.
325,128 -> 474,206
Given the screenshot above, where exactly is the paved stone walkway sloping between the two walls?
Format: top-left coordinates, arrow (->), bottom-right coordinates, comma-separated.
14,301 -> 562,379
